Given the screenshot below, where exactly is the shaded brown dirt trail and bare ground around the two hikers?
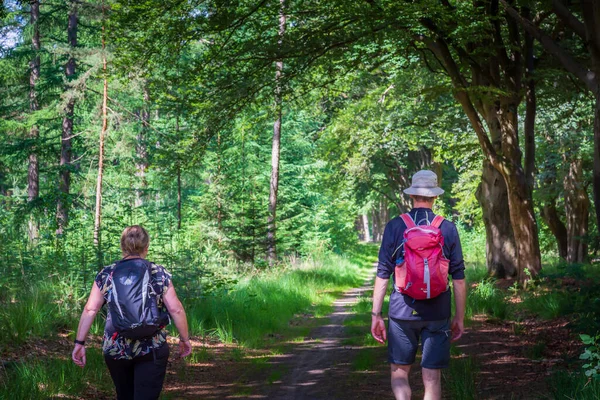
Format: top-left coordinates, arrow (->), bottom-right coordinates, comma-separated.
17,270 -> 581,400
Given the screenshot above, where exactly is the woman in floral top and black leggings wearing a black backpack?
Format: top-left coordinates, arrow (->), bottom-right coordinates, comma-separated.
72,225 -> 192,400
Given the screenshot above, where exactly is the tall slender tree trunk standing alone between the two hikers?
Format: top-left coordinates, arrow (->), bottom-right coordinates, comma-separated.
267,0 -> 286,265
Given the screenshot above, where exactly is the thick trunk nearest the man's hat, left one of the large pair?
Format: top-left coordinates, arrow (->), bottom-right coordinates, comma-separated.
475,160 -> 517,278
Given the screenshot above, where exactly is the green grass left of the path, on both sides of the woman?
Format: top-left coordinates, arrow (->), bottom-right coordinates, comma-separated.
0,246 -> 374,399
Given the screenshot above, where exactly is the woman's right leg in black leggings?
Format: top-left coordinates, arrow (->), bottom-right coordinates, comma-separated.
134,343 -> 169,400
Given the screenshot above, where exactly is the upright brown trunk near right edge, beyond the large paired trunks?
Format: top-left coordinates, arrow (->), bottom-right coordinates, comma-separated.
564,160 -> 590,264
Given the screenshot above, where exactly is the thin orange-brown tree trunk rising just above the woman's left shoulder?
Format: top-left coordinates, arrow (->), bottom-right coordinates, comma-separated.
94,17 -> 108,260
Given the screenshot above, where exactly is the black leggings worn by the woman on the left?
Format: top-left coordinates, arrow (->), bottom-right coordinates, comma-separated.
104,343 -> 169,400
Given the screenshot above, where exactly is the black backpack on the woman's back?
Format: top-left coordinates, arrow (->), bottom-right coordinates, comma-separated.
108,258 -> 169,340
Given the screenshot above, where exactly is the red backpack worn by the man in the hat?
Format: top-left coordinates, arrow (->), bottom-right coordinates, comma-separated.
394,214 -> 450,300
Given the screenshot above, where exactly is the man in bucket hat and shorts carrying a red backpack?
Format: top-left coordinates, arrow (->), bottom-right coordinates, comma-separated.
371,170 -> 467,400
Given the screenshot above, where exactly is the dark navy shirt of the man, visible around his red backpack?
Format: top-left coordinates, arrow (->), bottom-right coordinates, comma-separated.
377,208 -> 465,321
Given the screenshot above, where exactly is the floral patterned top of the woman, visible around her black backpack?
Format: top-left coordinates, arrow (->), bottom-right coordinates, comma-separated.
95,258 -> 171,360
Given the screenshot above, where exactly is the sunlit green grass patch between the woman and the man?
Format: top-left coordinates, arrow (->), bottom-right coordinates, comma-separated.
183,255 -> 371,347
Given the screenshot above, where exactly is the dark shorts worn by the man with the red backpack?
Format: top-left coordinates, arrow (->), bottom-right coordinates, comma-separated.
388,318 -> 452,369
